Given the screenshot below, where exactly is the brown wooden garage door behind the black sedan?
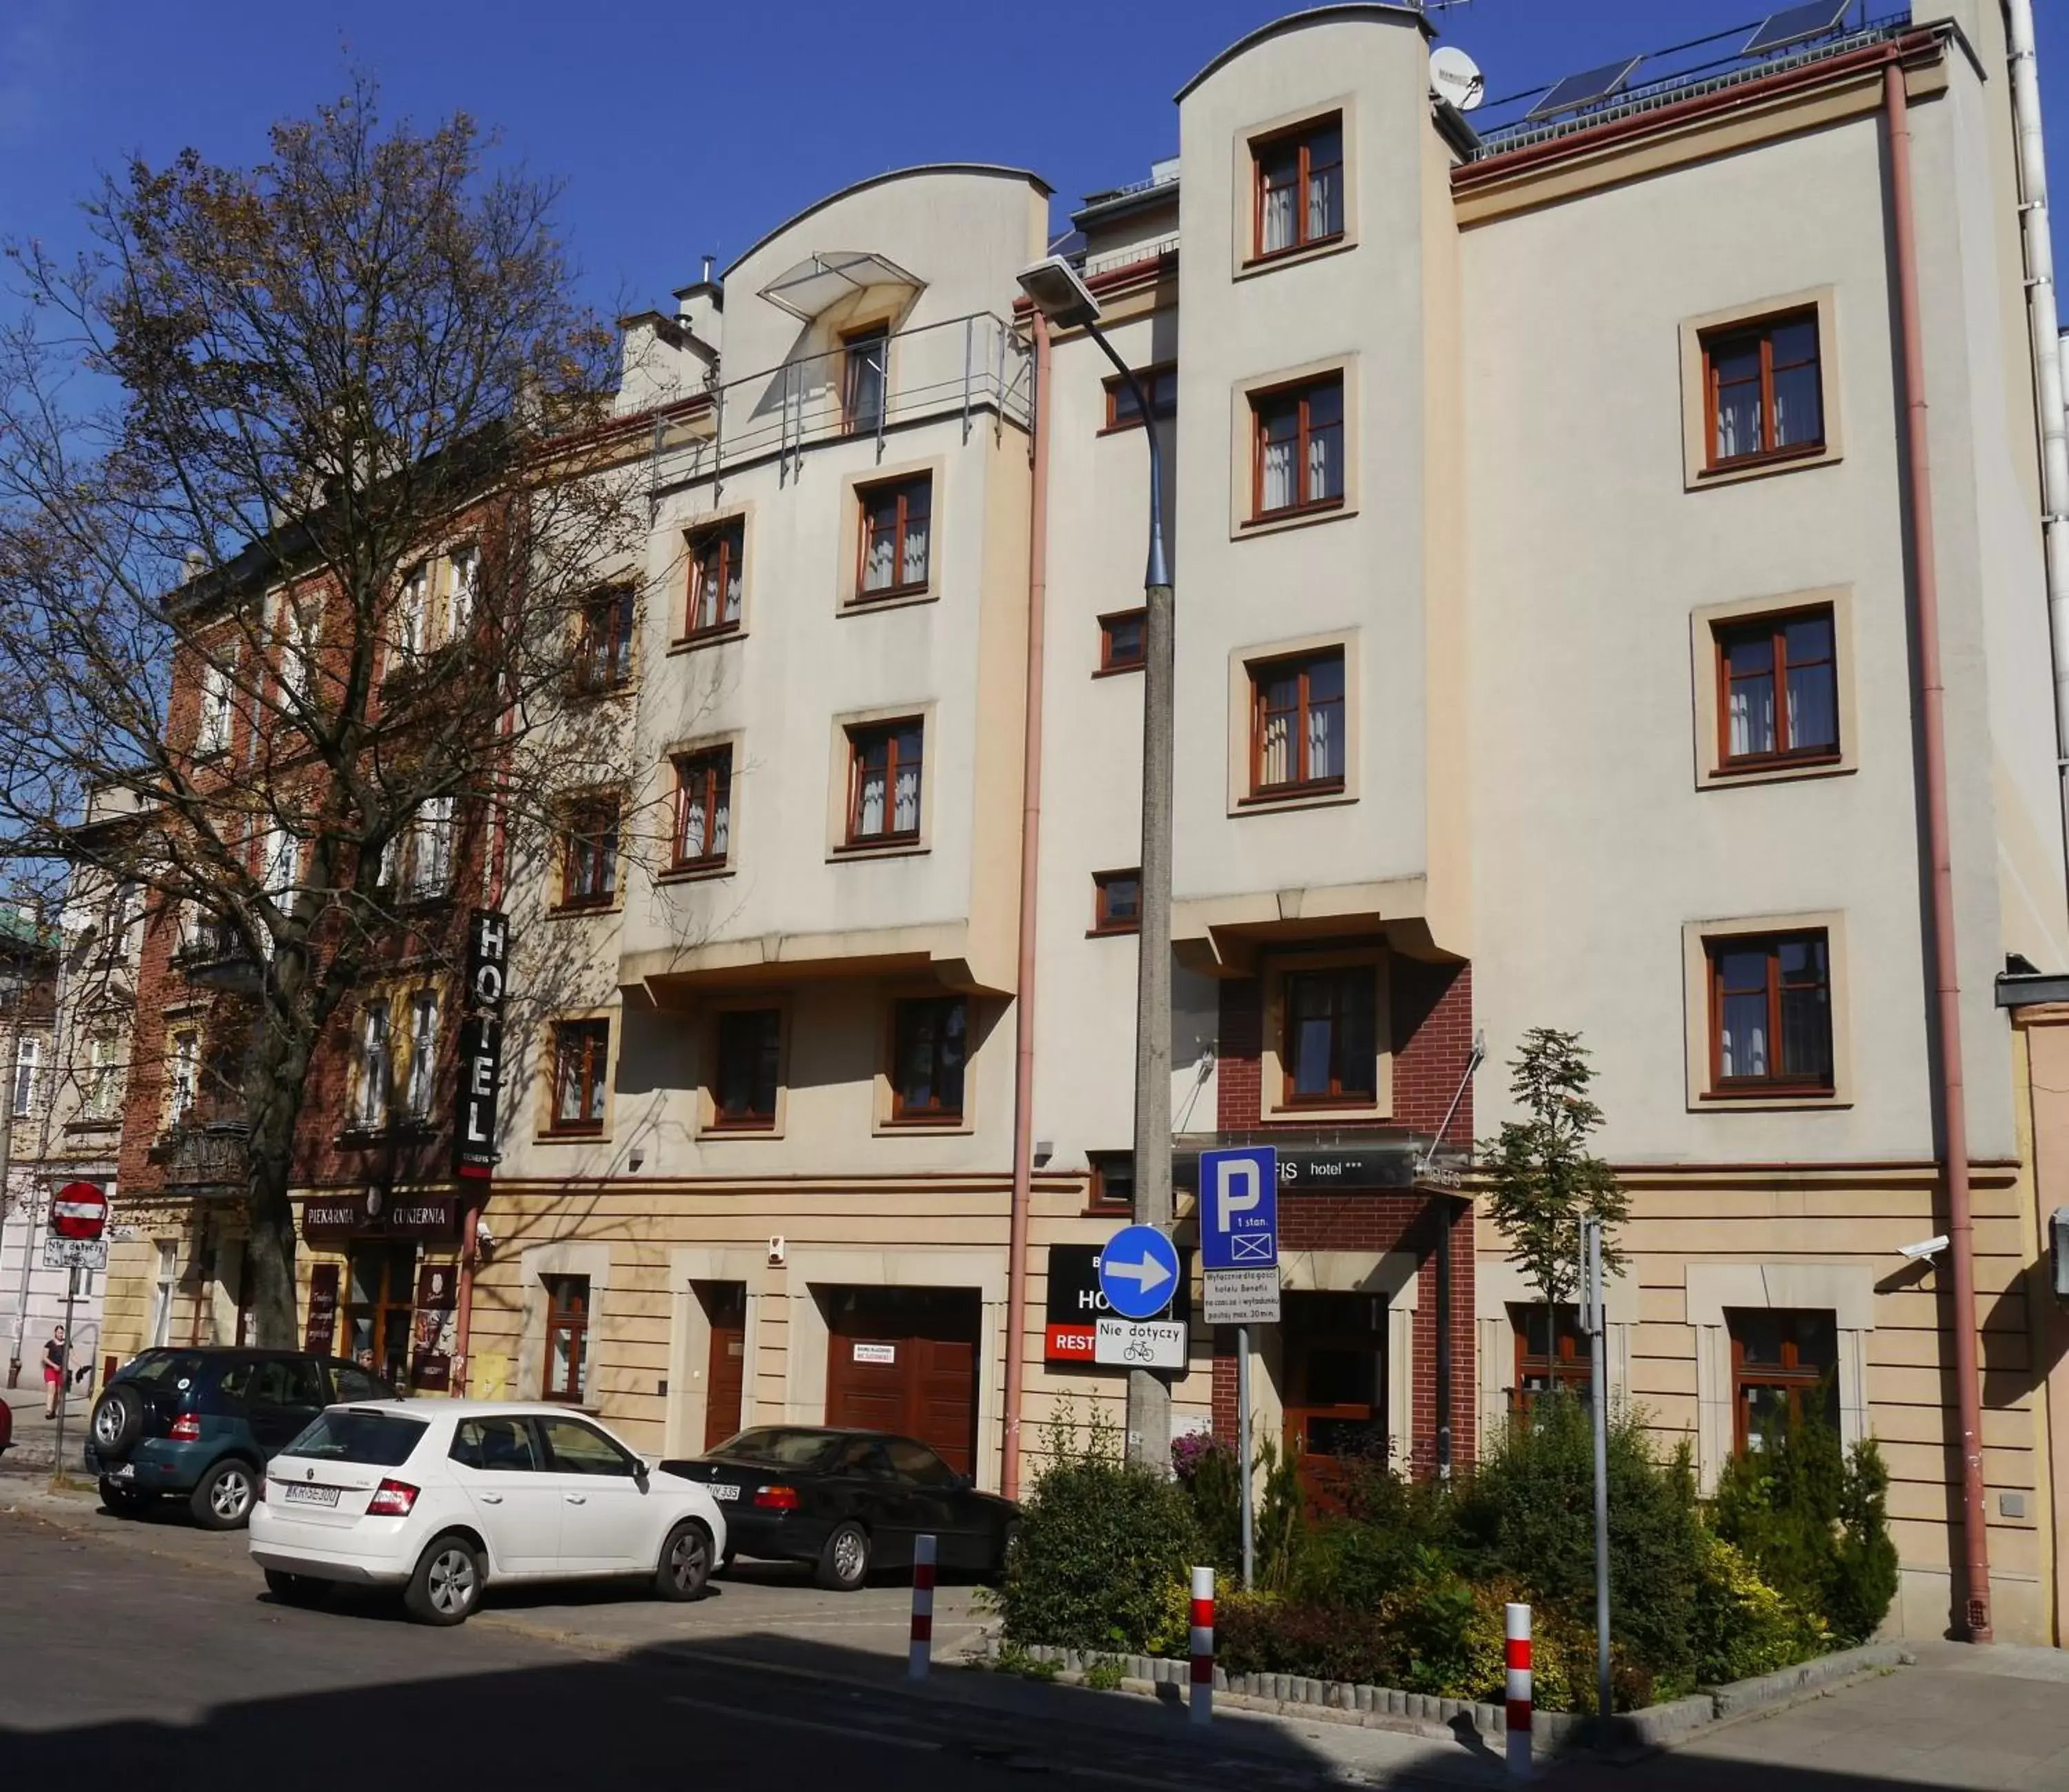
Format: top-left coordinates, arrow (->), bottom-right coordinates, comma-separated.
819,1287 -> 983,1473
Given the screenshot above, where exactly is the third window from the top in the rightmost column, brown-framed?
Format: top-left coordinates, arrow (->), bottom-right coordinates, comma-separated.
1707,929 -> 1833,1095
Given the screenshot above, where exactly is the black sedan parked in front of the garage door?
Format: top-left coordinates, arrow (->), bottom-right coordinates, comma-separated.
662,1426 -> 1020,1593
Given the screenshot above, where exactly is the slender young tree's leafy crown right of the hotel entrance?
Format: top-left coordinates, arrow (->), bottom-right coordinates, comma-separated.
1479,1026 -> 1630,1339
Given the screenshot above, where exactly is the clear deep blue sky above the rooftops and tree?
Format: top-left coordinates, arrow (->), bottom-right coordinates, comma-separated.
0,0 -> 2069,308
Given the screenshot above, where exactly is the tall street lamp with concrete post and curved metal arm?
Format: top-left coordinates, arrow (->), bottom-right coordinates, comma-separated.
1020,255 -> 1171,1469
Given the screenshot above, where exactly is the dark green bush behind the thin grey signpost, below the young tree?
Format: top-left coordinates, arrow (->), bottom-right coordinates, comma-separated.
1457,1395 -> 1703,1705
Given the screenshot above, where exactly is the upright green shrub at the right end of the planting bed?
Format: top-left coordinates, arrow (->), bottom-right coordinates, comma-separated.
1711,1413 -> 1897,1645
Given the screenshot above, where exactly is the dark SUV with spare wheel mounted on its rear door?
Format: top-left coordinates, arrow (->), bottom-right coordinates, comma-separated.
87,1345 -> 395,1531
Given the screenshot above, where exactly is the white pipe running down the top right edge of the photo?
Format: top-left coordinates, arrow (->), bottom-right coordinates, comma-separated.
2005,0 -> 2069,894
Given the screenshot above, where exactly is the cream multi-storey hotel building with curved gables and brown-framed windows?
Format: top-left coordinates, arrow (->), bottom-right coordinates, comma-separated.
101,0 -> 2069,1639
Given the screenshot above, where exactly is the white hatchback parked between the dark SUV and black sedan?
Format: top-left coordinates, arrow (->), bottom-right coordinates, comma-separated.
250,1401 -> 726,1624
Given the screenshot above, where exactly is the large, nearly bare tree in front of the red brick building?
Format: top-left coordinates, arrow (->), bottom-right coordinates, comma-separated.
0,83 -> 646,1345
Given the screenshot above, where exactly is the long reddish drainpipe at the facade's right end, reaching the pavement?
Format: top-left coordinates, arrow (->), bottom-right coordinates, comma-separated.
1883,54 -> 1990,1643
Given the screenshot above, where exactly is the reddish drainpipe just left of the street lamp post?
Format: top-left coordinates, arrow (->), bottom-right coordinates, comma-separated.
999,306 -> 1049,1500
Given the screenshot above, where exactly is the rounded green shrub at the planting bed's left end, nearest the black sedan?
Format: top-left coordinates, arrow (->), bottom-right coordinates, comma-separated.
999,1411 -> 1200,1653
